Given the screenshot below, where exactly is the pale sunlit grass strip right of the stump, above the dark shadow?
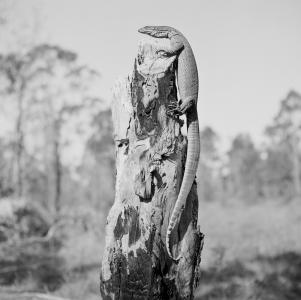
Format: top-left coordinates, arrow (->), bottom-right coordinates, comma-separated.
199,200 -> 301,267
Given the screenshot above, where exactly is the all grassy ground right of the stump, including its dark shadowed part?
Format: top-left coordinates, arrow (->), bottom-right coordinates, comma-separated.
196,200 -> 301,300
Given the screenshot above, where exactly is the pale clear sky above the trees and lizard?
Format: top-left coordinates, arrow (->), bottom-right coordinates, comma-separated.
0,0 -> 301,147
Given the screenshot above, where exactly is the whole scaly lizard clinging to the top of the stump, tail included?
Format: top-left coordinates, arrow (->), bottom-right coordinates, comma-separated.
138,26 -> 200,262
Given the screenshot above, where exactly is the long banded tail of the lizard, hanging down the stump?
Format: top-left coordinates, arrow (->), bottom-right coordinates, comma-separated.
166,105 -> 200,261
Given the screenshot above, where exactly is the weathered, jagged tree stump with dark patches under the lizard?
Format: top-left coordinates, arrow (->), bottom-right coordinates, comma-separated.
100,39 -> 203,299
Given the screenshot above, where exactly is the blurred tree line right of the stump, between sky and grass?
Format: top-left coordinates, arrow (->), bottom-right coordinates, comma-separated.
197,91 -> 301,203
